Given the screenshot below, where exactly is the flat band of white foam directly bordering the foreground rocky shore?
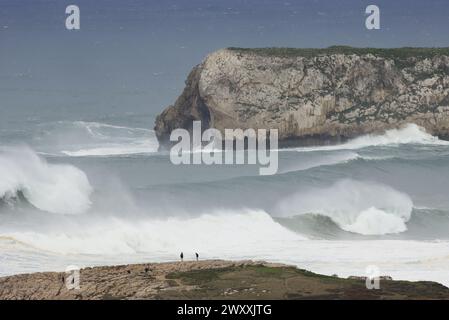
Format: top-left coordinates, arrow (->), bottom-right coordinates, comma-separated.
0,230 -> 449,286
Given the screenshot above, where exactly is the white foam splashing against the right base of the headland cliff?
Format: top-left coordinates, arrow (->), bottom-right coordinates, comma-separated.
289,124 -> 449,152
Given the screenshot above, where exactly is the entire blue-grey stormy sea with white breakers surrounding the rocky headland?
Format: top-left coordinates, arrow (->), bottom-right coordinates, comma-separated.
0,0 -> 449,286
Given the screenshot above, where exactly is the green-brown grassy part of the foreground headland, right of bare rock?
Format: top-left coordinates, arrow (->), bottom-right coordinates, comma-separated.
163,264 -> 449,300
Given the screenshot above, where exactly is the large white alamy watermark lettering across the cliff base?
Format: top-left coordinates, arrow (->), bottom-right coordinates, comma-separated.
170,121 -> 278,175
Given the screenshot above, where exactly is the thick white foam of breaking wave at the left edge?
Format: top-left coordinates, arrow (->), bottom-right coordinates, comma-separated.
0,147 -> 92,214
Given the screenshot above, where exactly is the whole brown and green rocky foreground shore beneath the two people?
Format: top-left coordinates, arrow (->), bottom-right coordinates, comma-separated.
0,261 -> 449,299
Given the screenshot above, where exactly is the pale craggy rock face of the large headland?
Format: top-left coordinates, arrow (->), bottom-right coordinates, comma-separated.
155,47 -> 449,145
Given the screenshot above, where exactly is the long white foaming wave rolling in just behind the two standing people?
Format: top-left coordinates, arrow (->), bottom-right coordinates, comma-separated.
1,209 -> 305,255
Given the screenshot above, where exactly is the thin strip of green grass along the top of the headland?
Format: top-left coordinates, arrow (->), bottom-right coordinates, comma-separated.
228,46 -> 449,59
